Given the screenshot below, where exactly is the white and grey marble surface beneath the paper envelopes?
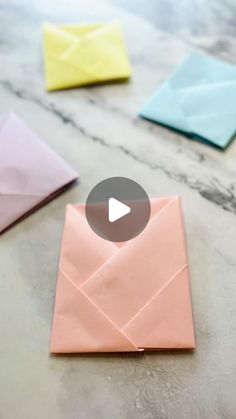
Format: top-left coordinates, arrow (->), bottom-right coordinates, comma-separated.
0,0 -> 236,419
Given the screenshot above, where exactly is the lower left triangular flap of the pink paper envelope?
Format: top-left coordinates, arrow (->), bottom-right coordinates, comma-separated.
51,272 -> 138,353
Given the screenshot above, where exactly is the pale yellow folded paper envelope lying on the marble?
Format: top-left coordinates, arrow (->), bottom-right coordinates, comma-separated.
43,22 -> 131,90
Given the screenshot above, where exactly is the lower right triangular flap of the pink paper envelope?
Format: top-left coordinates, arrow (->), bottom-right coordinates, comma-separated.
122,267 -> 195,349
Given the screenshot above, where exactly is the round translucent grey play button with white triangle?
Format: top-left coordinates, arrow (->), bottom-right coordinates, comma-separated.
85,177 -> 151,242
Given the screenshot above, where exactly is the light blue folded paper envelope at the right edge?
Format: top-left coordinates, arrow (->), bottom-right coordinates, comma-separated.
140,52 -> 236,149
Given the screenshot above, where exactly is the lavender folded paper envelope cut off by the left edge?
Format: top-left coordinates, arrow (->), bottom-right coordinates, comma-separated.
0,113 -> 78,233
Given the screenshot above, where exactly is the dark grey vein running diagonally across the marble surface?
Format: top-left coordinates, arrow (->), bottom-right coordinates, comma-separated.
0,80 -> 236,214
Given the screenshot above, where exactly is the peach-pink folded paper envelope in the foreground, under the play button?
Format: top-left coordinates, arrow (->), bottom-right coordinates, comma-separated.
51,197 -> 195,353
